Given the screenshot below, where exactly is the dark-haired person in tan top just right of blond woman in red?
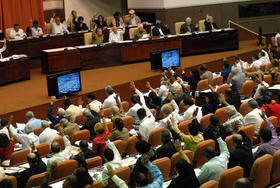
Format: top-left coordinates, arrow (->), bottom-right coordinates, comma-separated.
111,118 -> 129,149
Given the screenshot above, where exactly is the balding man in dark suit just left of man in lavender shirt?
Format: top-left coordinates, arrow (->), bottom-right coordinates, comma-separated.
228,130 -> 254,177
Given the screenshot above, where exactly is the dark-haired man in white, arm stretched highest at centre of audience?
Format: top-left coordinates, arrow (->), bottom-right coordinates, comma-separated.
130,82 -> 156,141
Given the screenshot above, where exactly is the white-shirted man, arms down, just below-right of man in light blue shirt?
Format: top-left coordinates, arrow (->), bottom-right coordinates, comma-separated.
39,120 -> 59,146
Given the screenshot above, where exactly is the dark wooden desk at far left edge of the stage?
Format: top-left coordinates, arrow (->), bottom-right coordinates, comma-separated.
0,57 -> 30,85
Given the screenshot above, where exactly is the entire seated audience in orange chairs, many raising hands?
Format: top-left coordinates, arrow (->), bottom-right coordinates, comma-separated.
0,54 -> 280,187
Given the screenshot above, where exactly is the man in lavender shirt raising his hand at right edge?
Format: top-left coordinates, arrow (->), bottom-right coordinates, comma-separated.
254,109 -> 280,159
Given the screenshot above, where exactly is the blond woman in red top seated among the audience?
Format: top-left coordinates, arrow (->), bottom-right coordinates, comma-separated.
92,123 -> 110,157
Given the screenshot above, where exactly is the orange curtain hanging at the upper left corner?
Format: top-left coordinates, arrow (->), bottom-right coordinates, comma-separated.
1,0 -> 45,31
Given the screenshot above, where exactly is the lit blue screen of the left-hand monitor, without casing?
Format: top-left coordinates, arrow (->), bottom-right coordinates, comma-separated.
57,72 -> 81,95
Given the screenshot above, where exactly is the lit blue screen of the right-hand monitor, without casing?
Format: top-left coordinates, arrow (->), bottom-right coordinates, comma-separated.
161,49 -> 180,69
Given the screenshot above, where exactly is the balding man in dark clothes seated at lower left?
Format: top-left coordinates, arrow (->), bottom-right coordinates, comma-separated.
17,145 -> 47,188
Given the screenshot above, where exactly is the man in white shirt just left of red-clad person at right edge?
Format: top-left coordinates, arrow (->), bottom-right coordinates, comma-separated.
244,100 -> 263,134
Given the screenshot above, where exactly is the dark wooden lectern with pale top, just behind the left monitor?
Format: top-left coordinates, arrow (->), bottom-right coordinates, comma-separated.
42,47 -> 81,74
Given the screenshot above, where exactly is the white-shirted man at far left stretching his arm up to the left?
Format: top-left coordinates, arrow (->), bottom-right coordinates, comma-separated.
10,124 -> 40,150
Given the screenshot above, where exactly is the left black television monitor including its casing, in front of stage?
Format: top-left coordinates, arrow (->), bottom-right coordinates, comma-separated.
47,71 -> 82,97
